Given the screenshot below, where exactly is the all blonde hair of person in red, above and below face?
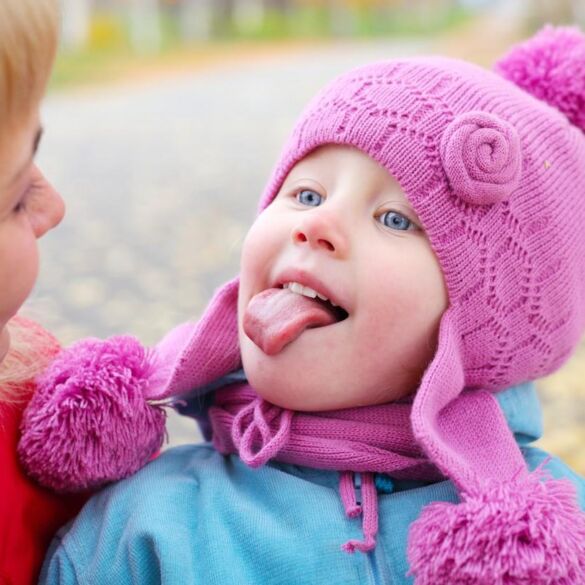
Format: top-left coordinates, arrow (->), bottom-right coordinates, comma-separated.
0,0 -> 59,403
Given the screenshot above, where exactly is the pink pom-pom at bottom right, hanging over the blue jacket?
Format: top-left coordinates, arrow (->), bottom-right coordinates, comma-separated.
408,471 -> 585,585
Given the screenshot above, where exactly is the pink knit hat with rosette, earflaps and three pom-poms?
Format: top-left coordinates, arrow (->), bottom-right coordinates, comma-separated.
21,28 -> 585,585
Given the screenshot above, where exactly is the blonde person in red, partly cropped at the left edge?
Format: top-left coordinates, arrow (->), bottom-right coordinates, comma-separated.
0,0 -> 89,585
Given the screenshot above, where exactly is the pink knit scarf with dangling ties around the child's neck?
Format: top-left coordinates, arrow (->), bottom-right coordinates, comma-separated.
209,384 -> 444,552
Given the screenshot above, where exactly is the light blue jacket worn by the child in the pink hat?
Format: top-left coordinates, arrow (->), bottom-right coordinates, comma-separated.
41,384 -> 585,585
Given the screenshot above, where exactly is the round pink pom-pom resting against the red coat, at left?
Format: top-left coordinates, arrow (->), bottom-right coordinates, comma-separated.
18,336 -> 166,492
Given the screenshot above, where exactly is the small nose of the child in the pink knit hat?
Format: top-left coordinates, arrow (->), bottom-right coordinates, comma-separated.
292,209 -> 349,257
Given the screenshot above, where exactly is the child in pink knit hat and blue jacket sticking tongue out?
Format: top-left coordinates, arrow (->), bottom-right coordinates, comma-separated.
21,28 -> 585,585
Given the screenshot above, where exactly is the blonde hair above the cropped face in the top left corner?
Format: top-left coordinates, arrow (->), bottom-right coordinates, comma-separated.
0,0 -> 59,130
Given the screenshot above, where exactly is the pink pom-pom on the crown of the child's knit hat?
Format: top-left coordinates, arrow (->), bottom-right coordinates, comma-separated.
495,26 -> 585,131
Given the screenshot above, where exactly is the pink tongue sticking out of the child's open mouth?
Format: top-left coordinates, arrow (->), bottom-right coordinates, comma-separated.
243,288 -> 337,355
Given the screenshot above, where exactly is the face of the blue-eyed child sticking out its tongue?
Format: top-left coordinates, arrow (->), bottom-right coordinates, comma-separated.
238,146 -> 447,411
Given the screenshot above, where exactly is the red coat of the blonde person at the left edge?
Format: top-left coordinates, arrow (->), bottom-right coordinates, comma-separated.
0,322 -> 86,585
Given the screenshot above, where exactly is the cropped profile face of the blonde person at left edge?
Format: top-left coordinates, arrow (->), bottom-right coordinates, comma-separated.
0,114 -> 64,361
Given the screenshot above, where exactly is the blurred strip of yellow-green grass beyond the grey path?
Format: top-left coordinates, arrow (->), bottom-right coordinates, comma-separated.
51,6 -> 470,89
